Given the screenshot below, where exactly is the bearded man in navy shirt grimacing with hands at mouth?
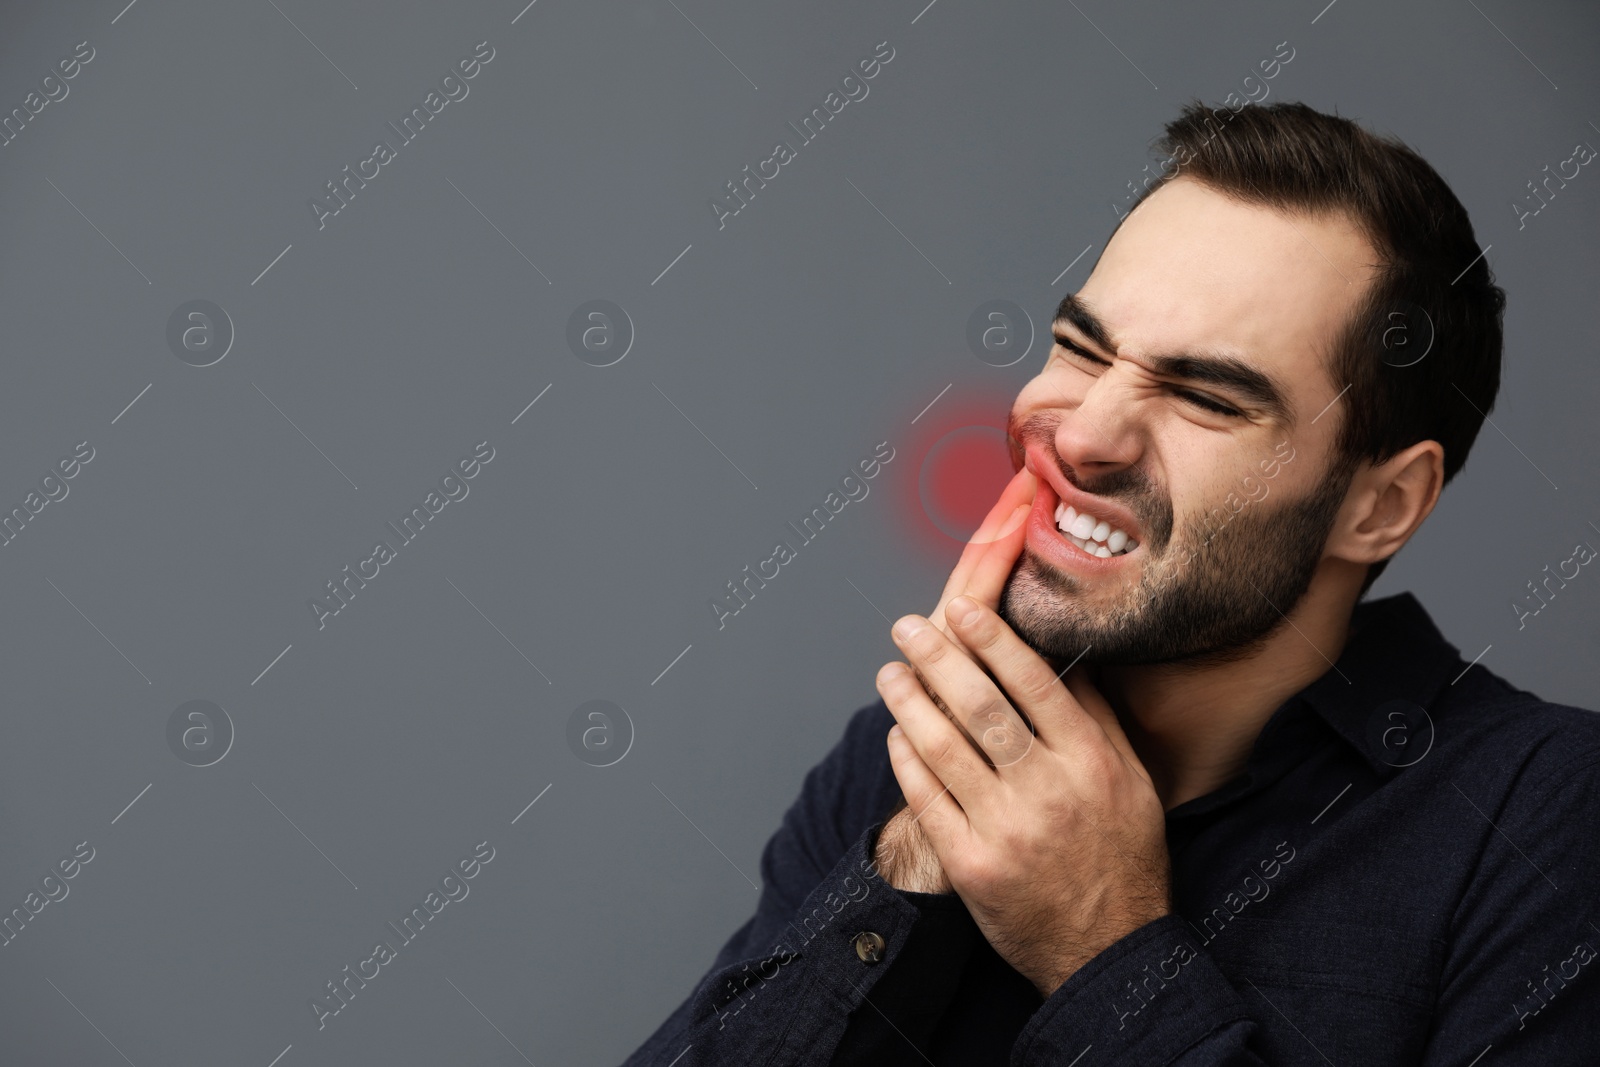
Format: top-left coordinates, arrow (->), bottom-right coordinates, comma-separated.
629,104 -> 1600,1067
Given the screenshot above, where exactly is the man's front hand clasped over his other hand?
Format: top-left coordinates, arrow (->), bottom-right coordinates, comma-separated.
878,597 -> 1171,997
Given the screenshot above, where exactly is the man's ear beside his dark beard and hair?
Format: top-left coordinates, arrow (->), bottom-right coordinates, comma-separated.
1328,442 -> 1445,563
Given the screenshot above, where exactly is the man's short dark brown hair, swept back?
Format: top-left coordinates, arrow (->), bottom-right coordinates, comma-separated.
1134,101 -> 1506,593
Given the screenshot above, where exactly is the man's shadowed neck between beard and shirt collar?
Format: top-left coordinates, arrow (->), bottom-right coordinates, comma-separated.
1096,568 -> 1365,811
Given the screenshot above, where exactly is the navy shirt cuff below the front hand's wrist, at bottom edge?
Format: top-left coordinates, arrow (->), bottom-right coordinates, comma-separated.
1011,913 -> 1250,1067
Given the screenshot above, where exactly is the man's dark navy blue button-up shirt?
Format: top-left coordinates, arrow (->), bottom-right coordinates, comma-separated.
626,593 -> 1600,1067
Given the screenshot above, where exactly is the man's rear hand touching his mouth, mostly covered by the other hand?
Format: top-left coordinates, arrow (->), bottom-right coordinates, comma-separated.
874,469 -> 1038,893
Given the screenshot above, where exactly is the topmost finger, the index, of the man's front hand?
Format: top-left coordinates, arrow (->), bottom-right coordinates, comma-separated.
950,597 -> 1122,764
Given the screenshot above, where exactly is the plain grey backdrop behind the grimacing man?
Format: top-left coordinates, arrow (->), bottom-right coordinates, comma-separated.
0,0 -> 1600,1067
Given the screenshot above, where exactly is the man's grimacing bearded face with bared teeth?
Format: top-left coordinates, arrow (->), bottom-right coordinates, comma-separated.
1002,178 -> 1376,662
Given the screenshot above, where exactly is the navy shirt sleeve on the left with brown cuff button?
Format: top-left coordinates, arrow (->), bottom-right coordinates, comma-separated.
624,701 -> 965,1067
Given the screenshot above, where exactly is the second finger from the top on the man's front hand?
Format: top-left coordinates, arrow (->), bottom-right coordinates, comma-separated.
893,616 -> 1034,777
